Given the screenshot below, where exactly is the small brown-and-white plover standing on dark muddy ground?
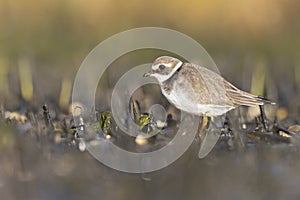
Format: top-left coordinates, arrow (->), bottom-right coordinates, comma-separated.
143,56 -> 274,117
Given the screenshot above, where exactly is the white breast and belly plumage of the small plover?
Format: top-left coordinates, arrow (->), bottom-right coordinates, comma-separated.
162,86 -> 235,117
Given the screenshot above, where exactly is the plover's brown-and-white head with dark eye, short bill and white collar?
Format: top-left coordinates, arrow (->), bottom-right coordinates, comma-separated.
144,56 -> 183,83
